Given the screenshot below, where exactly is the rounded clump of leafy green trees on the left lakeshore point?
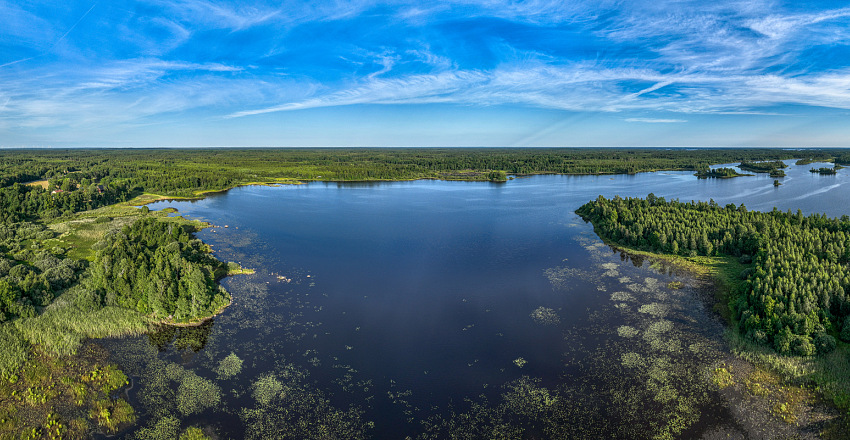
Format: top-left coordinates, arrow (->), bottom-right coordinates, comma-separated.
88,218 -> 230,322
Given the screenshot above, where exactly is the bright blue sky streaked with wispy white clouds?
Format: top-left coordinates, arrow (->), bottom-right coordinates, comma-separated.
0,0 -> 850,147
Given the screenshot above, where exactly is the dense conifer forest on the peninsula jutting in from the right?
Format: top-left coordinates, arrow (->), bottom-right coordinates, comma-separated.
577,194 -> 850,356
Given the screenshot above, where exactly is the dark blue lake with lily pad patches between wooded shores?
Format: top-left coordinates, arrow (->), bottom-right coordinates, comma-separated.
97,161 -> 850,439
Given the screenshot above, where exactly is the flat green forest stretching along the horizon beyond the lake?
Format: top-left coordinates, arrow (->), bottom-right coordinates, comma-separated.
9,148 -> 850,199
